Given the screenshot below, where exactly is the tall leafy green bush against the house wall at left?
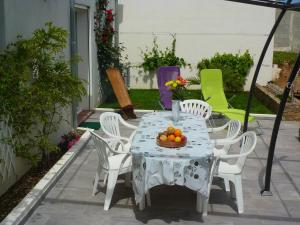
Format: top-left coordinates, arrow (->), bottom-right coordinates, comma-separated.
0,23 -> 85,165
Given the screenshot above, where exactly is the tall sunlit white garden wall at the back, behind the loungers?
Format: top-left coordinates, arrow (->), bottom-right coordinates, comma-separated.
118,0 -> 275,90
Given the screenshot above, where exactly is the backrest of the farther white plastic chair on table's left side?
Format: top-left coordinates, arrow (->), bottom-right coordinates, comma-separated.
100,112 -> 123,137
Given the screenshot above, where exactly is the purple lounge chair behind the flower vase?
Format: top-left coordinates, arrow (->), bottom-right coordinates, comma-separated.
156,66 -> 180,109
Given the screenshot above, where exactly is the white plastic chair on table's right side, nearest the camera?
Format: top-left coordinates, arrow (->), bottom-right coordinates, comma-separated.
197,131 -> 257,215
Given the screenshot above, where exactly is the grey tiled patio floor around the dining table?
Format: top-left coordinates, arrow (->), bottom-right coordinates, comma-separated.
22,111 -> 300,225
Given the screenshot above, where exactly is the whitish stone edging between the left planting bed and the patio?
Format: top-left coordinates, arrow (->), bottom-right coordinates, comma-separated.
0,132 -> 91,225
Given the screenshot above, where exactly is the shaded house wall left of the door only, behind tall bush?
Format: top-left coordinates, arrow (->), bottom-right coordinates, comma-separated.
0,0 -> 72,197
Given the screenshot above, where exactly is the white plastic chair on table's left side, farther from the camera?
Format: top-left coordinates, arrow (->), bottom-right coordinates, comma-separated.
100,112 -> 137,152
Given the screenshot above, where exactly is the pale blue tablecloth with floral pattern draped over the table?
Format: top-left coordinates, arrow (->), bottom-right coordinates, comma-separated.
131,112 -> 213,203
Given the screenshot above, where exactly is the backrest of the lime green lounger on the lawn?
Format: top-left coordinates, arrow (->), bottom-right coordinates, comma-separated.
200,69 -> 228,110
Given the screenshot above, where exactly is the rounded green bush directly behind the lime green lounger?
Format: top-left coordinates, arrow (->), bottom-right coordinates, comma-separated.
197,50 -> 253,92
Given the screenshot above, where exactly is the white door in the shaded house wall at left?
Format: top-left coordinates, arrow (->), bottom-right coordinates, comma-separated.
76,7 -> 91,113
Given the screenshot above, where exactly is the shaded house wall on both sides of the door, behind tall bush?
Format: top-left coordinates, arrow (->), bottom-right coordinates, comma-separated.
0,0 -> 99,195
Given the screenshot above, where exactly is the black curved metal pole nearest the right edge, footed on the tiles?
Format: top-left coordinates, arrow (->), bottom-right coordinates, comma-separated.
261,52 -> 300,195
